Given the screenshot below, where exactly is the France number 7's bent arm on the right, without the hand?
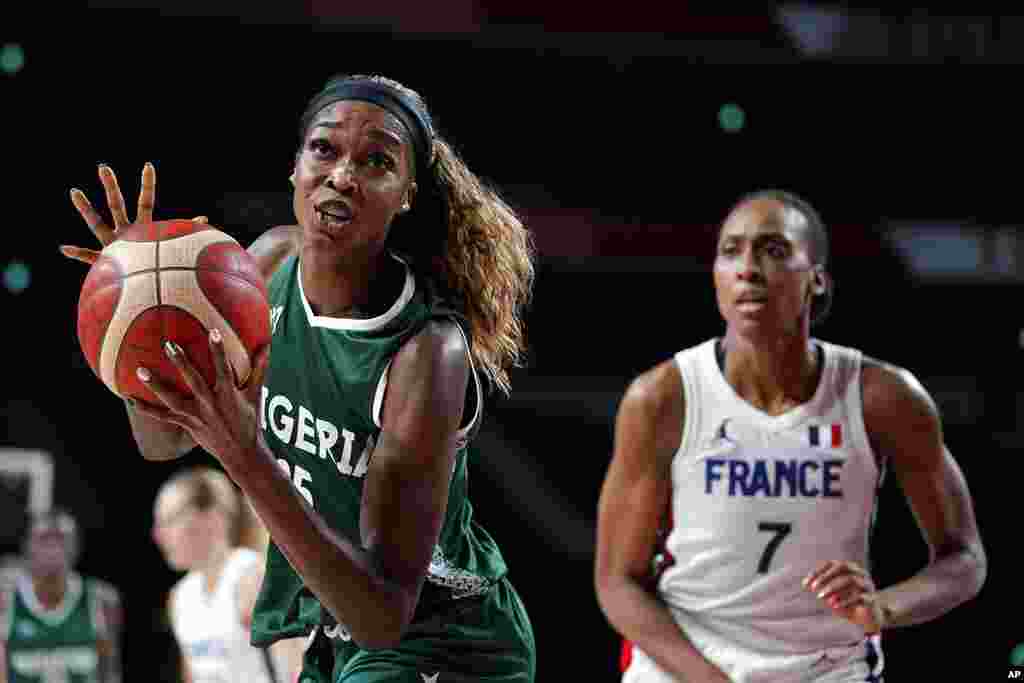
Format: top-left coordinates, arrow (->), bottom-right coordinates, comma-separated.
863,361 -> 986,627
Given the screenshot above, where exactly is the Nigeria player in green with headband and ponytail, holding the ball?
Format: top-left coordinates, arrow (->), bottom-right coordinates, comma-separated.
65,76 -> 535,683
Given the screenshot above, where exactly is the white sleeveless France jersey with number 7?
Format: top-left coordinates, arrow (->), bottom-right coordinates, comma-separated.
625,340 -> 882,683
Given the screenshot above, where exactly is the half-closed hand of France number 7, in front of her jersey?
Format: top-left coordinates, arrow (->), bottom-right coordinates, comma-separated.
803,560 -> 886,634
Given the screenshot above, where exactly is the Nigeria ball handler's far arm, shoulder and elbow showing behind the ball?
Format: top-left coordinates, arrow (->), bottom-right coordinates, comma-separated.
125,225 -> 296,461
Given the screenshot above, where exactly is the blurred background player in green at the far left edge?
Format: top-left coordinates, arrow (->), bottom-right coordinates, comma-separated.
0,508 -> 122,683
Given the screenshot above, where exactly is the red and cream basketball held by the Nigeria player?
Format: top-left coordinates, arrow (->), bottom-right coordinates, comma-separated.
78,220 -> 270,405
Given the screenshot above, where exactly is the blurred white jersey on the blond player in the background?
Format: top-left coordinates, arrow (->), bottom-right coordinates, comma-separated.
171,548 -> 274,683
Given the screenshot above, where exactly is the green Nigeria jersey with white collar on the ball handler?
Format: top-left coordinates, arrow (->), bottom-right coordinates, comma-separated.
252,256 -> 506,645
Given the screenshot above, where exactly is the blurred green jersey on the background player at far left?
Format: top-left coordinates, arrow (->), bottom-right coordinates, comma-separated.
0,573 -> 103,683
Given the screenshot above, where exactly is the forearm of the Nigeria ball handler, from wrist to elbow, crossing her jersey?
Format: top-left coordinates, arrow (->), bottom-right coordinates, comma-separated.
225,439 -> 412,649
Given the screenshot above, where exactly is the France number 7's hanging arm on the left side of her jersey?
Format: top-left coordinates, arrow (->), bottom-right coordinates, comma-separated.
594,361 -> 728,682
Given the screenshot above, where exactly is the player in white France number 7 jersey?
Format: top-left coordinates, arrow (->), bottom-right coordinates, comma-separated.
595,190 -> 985,683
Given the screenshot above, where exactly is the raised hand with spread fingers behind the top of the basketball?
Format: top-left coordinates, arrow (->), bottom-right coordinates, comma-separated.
60,162 -> 207,265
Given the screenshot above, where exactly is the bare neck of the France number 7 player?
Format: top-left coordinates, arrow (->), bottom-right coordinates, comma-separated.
723,331 -> 820,415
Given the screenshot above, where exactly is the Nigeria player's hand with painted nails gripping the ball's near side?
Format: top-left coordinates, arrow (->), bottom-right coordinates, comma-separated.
135,330 -> 269,470
